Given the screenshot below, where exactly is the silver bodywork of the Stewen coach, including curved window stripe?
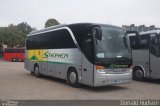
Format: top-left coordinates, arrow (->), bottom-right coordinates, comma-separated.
25,26 -> 132,86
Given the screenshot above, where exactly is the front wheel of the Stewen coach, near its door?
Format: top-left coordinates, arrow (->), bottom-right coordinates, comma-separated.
67,69 -> 80,88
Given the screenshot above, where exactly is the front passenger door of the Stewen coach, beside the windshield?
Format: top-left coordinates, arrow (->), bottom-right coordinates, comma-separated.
82,35 -> 94,86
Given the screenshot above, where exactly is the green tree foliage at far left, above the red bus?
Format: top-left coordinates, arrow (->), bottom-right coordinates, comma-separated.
0,22 -> 32,47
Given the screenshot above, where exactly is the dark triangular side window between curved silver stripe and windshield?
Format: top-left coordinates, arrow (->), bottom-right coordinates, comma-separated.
69,24 -> 94,63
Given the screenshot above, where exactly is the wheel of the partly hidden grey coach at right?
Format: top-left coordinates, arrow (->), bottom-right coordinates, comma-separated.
133,68 -> 144,80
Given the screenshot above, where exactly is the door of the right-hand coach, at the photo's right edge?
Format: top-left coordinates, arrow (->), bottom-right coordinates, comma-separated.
150,34 -> 160,78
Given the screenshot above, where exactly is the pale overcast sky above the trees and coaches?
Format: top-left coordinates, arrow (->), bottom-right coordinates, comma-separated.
0,0 -> 160,29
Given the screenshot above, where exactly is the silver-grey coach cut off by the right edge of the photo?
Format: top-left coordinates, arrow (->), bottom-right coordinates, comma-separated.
129,30 -> 160,80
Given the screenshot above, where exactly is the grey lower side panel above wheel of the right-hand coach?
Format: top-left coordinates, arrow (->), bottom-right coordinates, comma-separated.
132,49 -> 149,77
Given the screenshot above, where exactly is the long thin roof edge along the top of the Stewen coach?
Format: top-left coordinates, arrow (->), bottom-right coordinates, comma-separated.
27,23 -> 125,36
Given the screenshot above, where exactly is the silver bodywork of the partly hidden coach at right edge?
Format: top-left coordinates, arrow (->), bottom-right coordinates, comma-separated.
131,30 -> 160,79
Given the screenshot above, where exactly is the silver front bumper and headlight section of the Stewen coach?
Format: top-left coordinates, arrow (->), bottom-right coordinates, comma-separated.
94,68 -> 132,86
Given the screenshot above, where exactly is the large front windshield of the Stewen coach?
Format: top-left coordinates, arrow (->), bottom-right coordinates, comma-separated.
95,26 -> 131,63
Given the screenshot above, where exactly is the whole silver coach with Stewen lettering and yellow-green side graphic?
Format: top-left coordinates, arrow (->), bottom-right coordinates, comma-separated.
25,23 -> 132,87
